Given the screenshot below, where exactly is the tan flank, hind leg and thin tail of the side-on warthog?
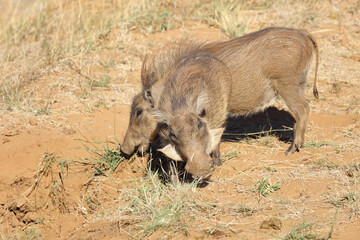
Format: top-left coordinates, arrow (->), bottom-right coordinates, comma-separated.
121,28 -> 318,175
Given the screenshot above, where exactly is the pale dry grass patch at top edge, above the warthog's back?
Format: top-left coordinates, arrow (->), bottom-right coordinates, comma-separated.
199,0 -> 323,38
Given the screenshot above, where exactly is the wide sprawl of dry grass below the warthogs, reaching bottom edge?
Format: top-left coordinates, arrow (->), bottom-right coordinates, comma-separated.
81,168 -> 255,239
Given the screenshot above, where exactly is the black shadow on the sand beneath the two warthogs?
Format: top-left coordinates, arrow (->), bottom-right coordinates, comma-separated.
148,107 -> 295,188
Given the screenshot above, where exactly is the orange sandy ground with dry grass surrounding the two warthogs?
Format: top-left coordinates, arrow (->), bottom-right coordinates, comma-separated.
0,0 -> 360,239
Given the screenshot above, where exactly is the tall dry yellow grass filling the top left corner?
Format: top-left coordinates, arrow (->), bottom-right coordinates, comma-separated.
0,0 -> 188,114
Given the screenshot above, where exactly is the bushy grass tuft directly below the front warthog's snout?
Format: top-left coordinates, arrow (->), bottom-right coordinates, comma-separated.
120,171 -> 195,238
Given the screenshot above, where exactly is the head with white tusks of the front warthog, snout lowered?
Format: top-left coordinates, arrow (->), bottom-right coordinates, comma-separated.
153,110 -> 224,180
